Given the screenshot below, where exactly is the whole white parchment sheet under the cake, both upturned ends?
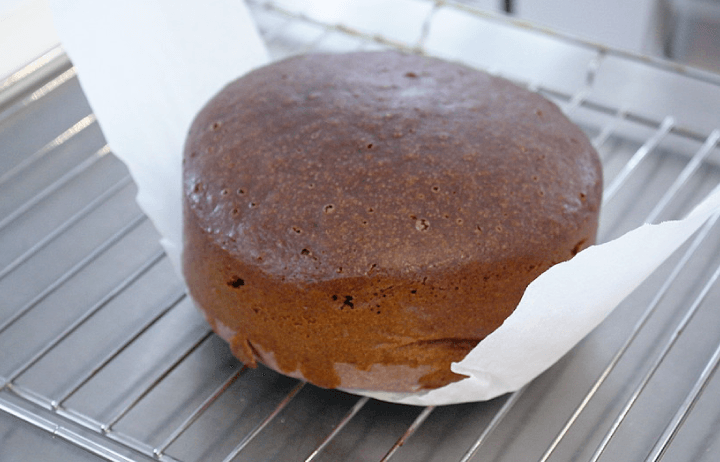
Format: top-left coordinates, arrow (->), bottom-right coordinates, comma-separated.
51,0 -> 720,405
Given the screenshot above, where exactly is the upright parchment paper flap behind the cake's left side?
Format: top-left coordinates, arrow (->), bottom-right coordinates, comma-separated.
50,0 -> 268,270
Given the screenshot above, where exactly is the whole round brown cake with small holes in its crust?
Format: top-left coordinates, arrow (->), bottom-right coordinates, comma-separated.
183,52 -> 602,392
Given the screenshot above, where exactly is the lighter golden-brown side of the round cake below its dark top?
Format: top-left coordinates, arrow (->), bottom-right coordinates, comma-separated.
184,202 -> 592,391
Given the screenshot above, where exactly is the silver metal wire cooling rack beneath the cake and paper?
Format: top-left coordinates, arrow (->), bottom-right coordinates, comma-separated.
0,0 -> 720,462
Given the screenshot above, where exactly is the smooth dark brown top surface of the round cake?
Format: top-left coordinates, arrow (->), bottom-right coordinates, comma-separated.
183,52 -> 602,281
